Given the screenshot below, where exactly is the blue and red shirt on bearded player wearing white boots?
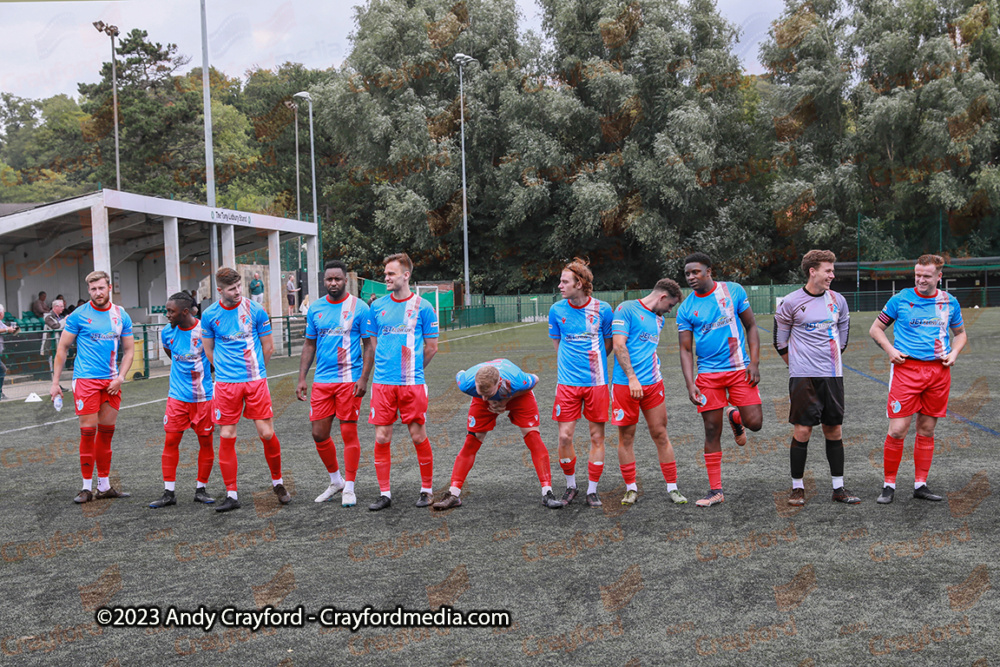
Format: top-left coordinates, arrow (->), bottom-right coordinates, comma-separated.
306,294 -> 368,383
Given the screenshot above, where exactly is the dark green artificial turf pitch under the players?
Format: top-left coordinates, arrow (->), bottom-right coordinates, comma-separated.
0,310 -> 1000,665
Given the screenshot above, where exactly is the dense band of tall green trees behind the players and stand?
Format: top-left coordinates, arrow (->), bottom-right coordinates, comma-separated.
0,0 -> 1000,292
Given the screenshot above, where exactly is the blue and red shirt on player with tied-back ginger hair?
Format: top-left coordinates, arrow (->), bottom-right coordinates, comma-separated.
549,297 -> 614,387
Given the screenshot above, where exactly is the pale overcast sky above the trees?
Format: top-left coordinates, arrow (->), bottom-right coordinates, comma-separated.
0,0 -> 783,99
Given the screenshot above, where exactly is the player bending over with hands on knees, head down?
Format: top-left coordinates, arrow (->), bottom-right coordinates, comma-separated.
433,359 -> 563,510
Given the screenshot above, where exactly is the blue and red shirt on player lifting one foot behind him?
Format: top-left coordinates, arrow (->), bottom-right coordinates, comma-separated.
677,280 -> 750,373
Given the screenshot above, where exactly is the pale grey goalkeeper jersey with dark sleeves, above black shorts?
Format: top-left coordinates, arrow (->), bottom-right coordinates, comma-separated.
774,288 -> 851,377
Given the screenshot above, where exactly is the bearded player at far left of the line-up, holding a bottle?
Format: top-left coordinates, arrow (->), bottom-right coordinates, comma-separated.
49,271 -> 135,503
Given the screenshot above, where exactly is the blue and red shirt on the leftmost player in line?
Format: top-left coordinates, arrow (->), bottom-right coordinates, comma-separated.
65,301 -> 132,380
